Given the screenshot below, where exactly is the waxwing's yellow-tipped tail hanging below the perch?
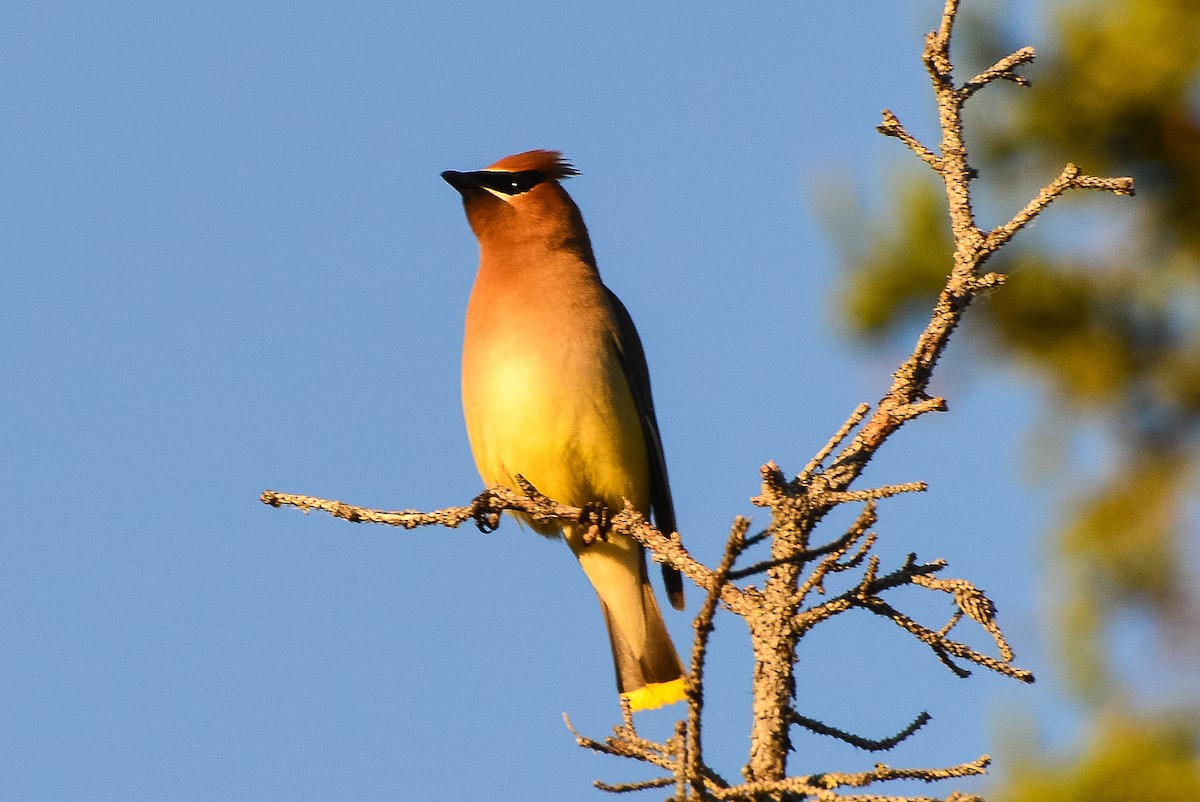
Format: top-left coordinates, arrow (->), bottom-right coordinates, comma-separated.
566,532 -> 684,710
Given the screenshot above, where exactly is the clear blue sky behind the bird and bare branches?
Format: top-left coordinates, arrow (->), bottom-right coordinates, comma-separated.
0,1 -> 1128,800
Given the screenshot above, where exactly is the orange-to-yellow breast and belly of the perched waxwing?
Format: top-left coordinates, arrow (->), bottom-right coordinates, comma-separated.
462,278 -> 649,523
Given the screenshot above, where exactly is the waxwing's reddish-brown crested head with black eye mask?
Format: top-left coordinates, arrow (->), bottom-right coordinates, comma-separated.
442,150 -> 592,261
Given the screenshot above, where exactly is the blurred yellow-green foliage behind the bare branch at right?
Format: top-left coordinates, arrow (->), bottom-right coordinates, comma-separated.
839,0 -> 1200,802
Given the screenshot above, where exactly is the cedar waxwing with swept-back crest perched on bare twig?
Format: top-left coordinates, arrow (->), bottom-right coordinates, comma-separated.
442,150 -> 684,710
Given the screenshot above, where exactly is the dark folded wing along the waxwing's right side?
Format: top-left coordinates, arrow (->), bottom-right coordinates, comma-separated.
605,287 -> 684,610
